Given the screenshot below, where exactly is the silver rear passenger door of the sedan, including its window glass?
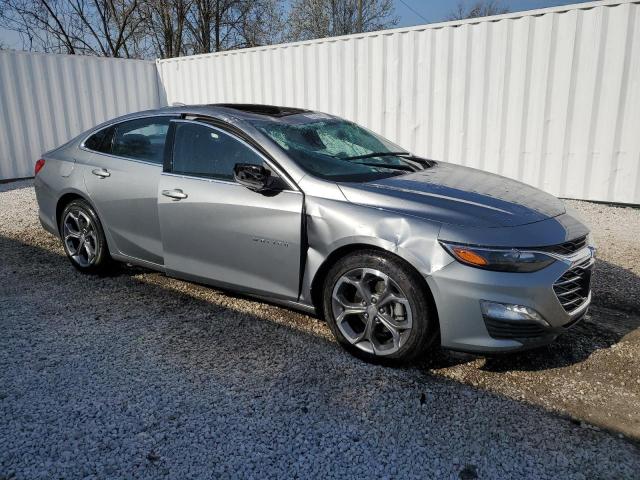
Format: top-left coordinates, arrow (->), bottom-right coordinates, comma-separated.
83,116 -> 178,265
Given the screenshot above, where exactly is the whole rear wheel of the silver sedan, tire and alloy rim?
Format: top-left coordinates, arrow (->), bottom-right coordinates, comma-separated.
59,199 -> 110,273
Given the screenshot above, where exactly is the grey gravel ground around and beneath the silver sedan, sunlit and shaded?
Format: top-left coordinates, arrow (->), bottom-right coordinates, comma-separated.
0,182 -> 640,479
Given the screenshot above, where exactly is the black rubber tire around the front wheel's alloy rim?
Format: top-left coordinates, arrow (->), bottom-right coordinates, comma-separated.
322,250 -> 439,366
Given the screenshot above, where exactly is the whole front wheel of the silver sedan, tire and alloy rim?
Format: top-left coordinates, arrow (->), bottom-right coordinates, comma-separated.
323,250 -> 438,363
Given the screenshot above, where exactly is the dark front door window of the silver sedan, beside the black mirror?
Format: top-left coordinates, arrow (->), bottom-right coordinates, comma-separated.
172,122 -> 264,180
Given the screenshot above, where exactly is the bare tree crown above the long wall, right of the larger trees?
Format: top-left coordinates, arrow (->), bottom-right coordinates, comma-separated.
288,0 -> 398,40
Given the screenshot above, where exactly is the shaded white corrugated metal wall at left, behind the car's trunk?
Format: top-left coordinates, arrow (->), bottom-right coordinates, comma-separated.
0,51 -> 160,179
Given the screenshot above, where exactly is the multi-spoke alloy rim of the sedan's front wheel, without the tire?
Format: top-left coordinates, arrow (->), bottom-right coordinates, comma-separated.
331,268 -> 413,356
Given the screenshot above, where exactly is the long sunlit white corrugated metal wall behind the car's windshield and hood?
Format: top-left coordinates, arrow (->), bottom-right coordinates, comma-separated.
158,1 -> 640,203
